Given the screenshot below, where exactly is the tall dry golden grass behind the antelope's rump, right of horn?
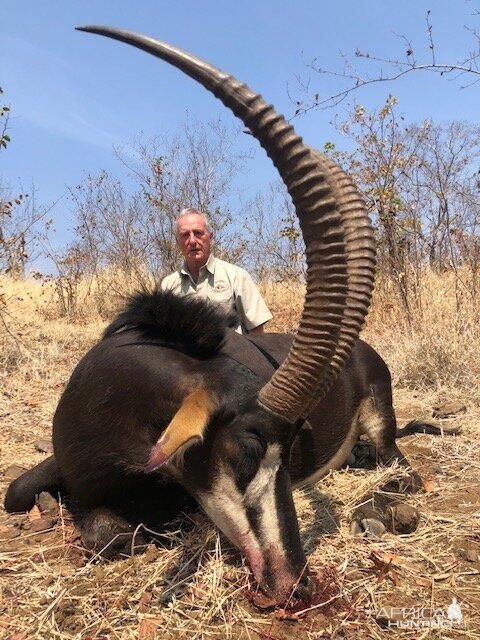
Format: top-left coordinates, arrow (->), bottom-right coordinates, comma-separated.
365,272 -> 480,393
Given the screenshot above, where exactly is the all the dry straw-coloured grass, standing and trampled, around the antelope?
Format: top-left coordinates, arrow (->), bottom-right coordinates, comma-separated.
0,272 -> 480,640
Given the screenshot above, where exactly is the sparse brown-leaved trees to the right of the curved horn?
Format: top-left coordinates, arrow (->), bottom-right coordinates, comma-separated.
326,96 -> 480,314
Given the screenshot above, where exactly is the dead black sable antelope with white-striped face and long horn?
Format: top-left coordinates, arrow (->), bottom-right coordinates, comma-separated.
5,27 -> 440,603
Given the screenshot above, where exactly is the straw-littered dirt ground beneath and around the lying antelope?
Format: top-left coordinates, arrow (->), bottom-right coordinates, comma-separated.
0,318 -> 480,640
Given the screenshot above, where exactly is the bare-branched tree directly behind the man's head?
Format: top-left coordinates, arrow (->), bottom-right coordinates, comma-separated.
117,119 -> 246,277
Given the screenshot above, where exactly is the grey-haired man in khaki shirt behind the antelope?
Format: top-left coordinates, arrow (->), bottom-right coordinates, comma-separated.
160,209 -> 272,333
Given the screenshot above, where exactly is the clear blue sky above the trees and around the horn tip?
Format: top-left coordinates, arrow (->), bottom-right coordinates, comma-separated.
0,0 -> 480,245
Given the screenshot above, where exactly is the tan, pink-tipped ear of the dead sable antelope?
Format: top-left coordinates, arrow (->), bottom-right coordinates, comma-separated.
146,388 -> 218,472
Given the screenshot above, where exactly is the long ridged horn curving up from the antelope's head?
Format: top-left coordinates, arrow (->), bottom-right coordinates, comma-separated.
79,26 -> 375,423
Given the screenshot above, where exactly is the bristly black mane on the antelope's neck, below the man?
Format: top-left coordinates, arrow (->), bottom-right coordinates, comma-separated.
102,289 -> 236,358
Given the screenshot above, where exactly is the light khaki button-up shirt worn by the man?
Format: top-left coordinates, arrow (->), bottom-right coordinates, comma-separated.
160,255 -> 272,333
